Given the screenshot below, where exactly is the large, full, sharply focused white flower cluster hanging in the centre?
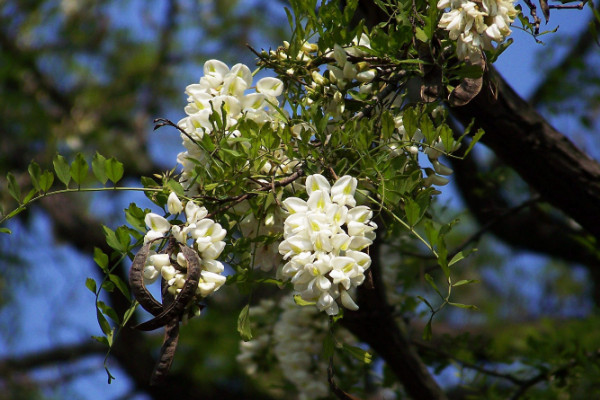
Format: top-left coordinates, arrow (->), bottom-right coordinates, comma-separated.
278,174 -> 377,315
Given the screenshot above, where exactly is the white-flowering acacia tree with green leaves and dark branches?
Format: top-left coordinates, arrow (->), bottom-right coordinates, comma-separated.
4,1 -> 600,399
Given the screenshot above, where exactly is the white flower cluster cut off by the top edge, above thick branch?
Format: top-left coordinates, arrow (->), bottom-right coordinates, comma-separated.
437,0 -> 518,63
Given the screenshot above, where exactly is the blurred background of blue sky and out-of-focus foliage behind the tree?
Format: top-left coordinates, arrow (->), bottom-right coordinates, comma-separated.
0,0 -> 600,399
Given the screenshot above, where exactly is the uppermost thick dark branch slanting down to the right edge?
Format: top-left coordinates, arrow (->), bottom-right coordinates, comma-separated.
451,70 -> 600,238
